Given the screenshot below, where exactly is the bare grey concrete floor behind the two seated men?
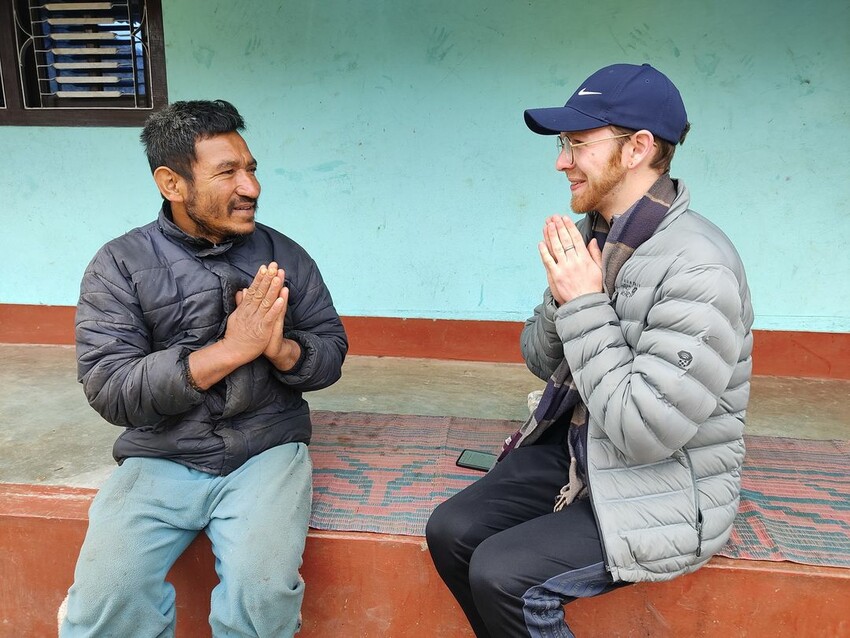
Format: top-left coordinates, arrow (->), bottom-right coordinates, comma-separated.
0,344 -> 850,487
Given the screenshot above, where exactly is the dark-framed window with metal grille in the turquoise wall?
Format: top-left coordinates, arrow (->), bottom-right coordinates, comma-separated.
0,0 -> 168,126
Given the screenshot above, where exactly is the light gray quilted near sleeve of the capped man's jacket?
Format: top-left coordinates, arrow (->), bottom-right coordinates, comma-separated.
555,265 -> 745,463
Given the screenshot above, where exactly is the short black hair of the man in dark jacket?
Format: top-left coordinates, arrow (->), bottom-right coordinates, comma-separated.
139,100 -> 245,183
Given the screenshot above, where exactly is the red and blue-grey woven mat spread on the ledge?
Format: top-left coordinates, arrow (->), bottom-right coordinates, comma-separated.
310,411 -> 850,567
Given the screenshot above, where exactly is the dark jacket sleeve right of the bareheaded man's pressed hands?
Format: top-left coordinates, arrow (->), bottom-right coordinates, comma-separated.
274,255 -> 348,391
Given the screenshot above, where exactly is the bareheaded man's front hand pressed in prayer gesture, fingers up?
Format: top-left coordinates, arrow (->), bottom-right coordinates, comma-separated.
222,262 -> 289,362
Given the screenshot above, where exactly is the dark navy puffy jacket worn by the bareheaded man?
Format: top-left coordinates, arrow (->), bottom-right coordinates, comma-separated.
76,204 -> 348,474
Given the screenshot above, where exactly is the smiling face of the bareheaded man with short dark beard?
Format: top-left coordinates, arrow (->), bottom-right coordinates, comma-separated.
169,132 -> 260,244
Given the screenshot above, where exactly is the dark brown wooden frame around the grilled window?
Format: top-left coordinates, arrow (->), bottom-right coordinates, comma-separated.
0,0 -> 168,126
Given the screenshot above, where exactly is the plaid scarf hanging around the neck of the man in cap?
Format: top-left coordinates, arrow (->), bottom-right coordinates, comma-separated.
499,173 -> 676,511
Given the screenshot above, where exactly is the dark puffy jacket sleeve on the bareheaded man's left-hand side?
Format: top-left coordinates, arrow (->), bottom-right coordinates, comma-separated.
75,250 -> 203,428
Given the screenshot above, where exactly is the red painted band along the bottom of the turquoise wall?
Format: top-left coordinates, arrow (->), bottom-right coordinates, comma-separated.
0,304 -> 850,379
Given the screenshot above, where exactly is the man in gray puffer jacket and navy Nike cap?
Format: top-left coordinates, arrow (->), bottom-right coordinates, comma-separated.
426,64 -> 753,638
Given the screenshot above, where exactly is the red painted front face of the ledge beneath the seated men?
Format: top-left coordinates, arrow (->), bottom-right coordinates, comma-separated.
0,484 -> 850,638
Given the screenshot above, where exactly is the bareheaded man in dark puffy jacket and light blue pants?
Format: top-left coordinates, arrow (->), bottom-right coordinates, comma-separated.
61,100 -> 348,638
